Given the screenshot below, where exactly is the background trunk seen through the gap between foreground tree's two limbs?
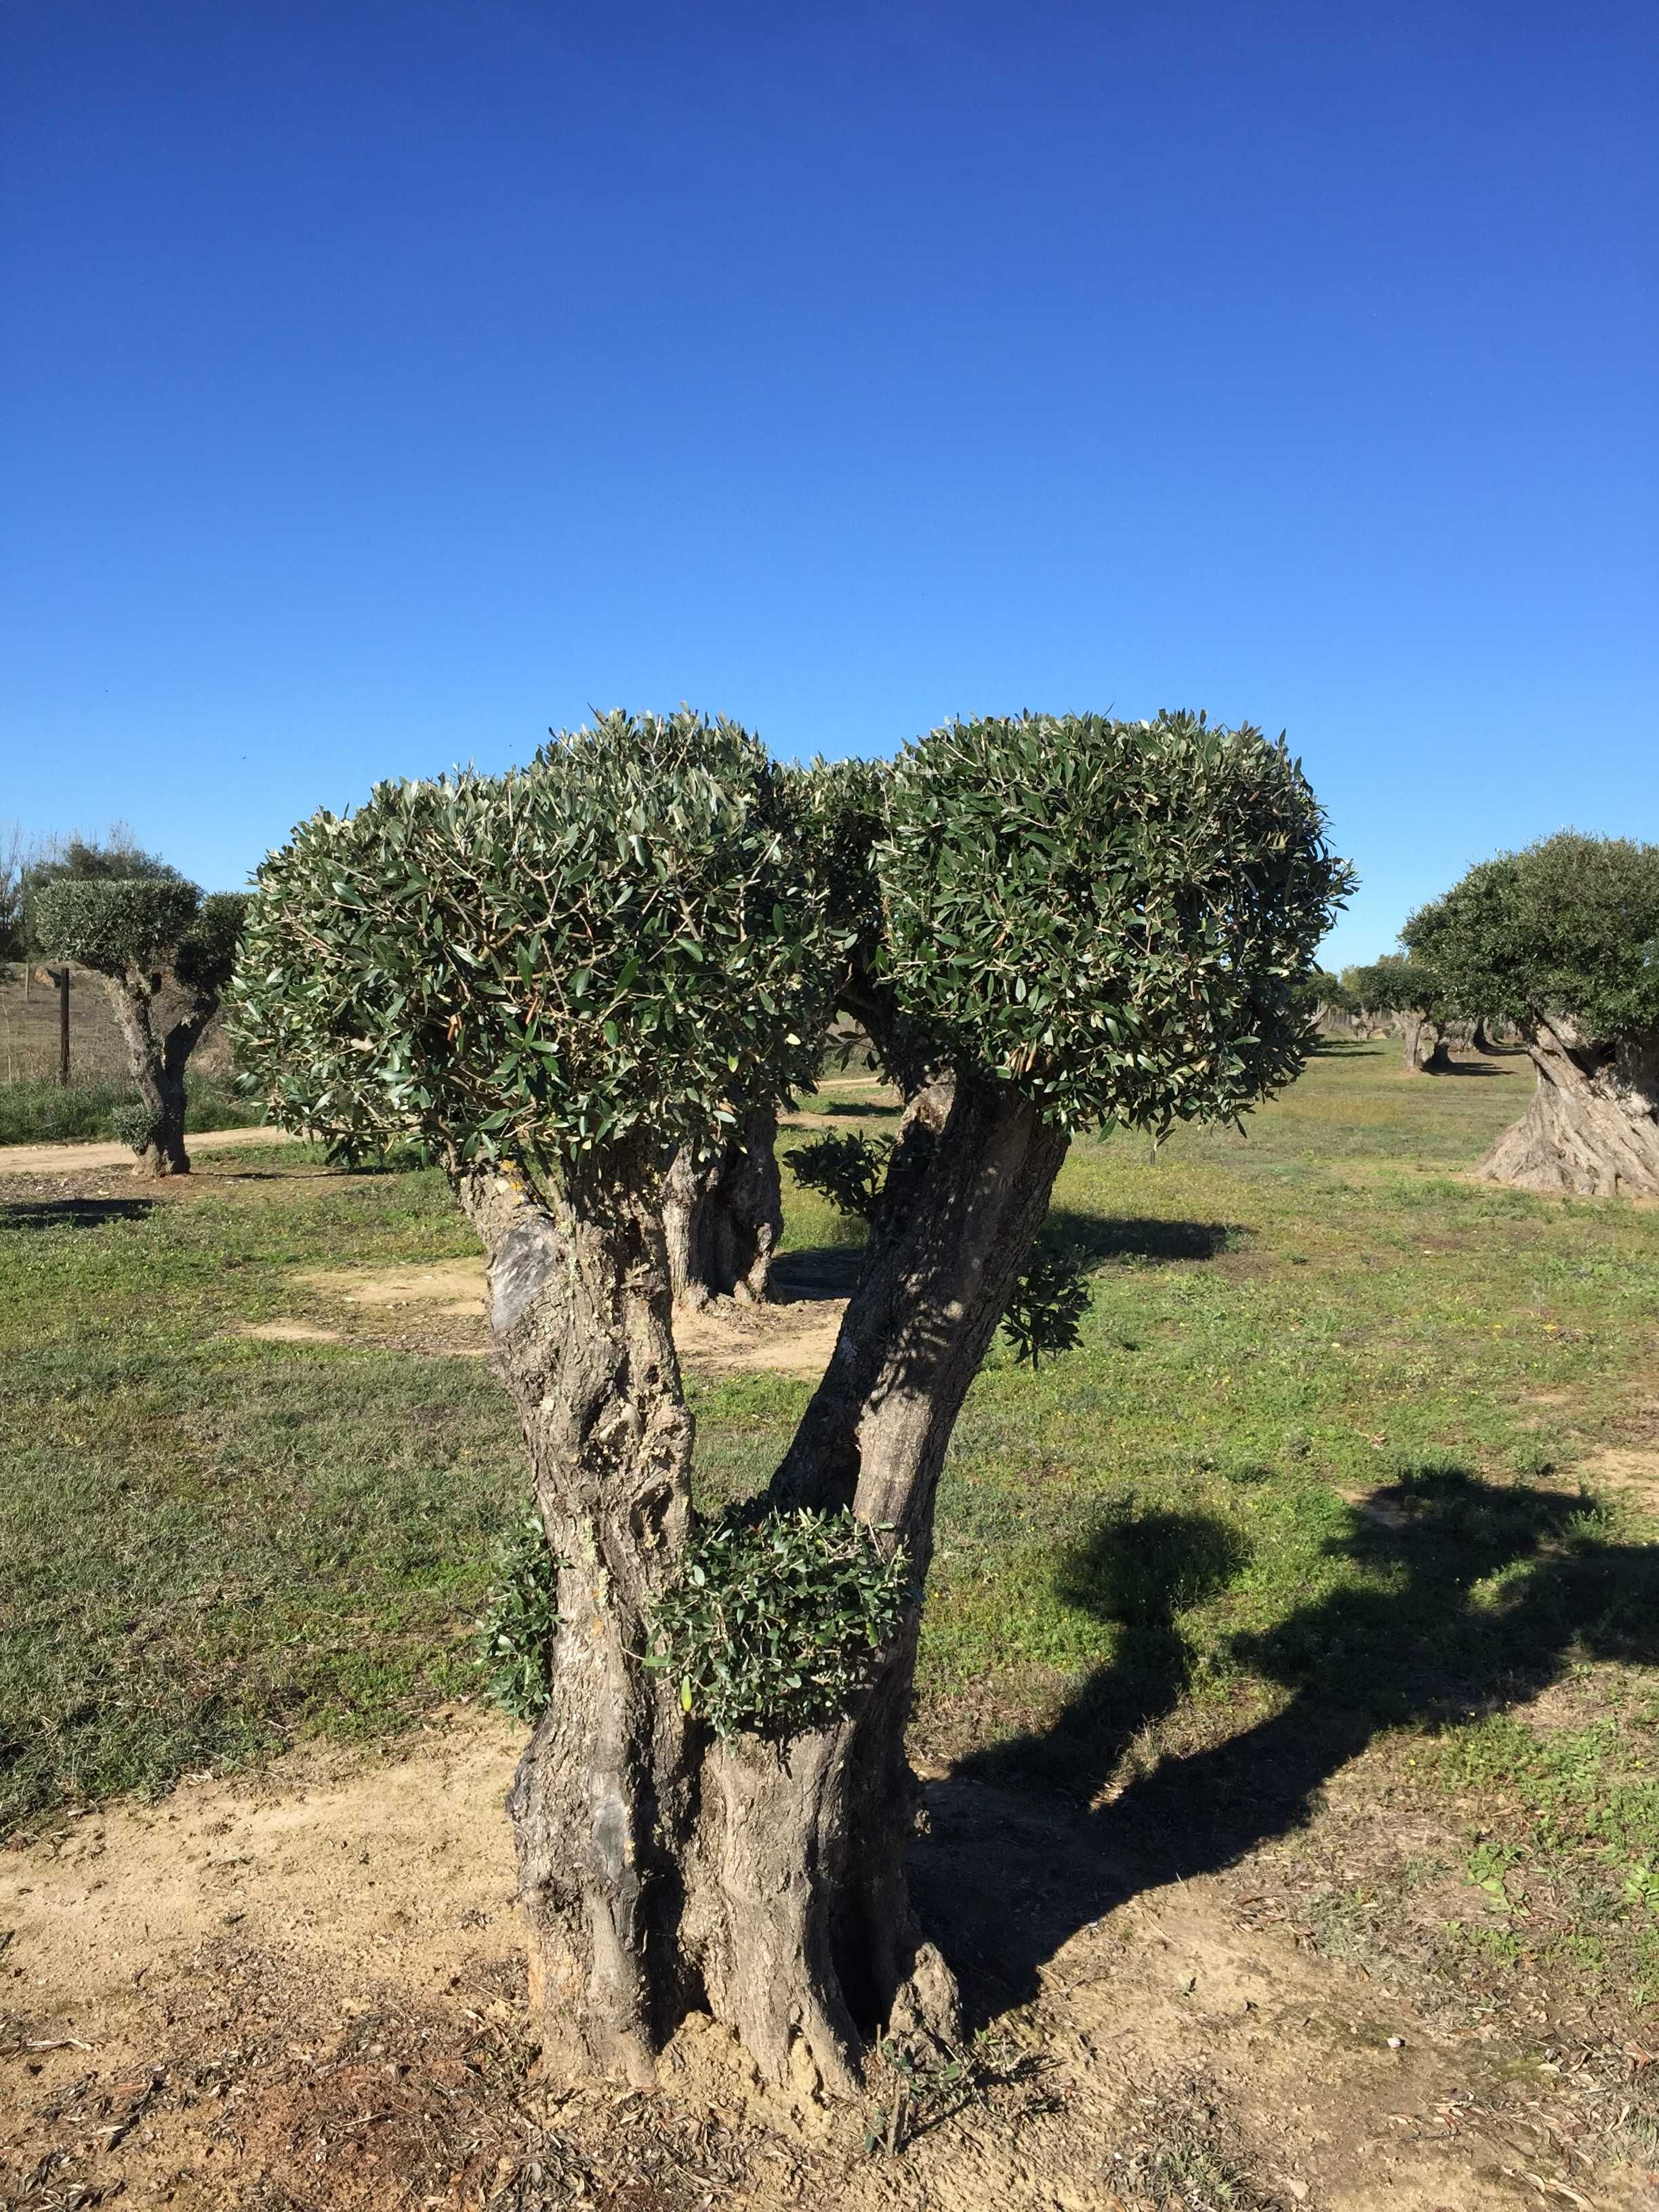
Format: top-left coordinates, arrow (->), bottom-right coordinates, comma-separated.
661,1106 -> 783,1305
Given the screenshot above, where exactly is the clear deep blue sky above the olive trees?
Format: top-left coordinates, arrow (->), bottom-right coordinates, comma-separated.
0,0 -> 1659,960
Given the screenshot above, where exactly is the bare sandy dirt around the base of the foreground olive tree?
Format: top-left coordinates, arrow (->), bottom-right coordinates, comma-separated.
0,1710 -> 1654,2212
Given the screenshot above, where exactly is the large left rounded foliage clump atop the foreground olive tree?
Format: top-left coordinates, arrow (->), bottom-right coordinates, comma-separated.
234,714 -> 825,1176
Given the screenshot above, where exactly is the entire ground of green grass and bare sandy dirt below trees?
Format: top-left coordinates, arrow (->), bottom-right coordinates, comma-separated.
0,1046 -> 1659,2212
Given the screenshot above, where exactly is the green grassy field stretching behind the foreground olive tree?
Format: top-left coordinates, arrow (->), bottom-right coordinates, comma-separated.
0,1046 -> 1659,2043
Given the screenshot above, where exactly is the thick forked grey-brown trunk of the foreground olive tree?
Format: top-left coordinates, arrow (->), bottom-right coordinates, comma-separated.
468,1084 -> 1066,2093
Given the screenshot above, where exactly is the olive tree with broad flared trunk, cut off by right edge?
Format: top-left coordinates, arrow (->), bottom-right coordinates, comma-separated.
1402,830 -> 1659,1199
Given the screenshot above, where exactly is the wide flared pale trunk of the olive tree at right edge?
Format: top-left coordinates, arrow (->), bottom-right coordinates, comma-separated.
1473,1015 -> 1659,1199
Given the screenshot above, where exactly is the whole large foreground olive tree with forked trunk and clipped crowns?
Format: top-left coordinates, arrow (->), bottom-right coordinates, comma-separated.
237,712 -> 1347,2090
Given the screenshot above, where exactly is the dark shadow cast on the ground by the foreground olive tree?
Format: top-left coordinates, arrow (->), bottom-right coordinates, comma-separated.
916,1469 -> 1659,2018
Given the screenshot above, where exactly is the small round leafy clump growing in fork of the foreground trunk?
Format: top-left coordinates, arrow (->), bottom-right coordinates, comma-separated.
646,1509 -> 916,1736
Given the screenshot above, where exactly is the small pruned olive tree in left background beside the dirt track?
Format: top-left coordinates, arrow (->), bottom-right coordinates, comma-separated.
31,869 -> 248,1176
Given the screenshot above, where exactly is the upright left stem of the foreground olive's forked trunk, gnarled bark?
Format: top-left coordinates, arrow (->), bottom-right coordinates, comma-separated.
455,1164 -> 695,2081
